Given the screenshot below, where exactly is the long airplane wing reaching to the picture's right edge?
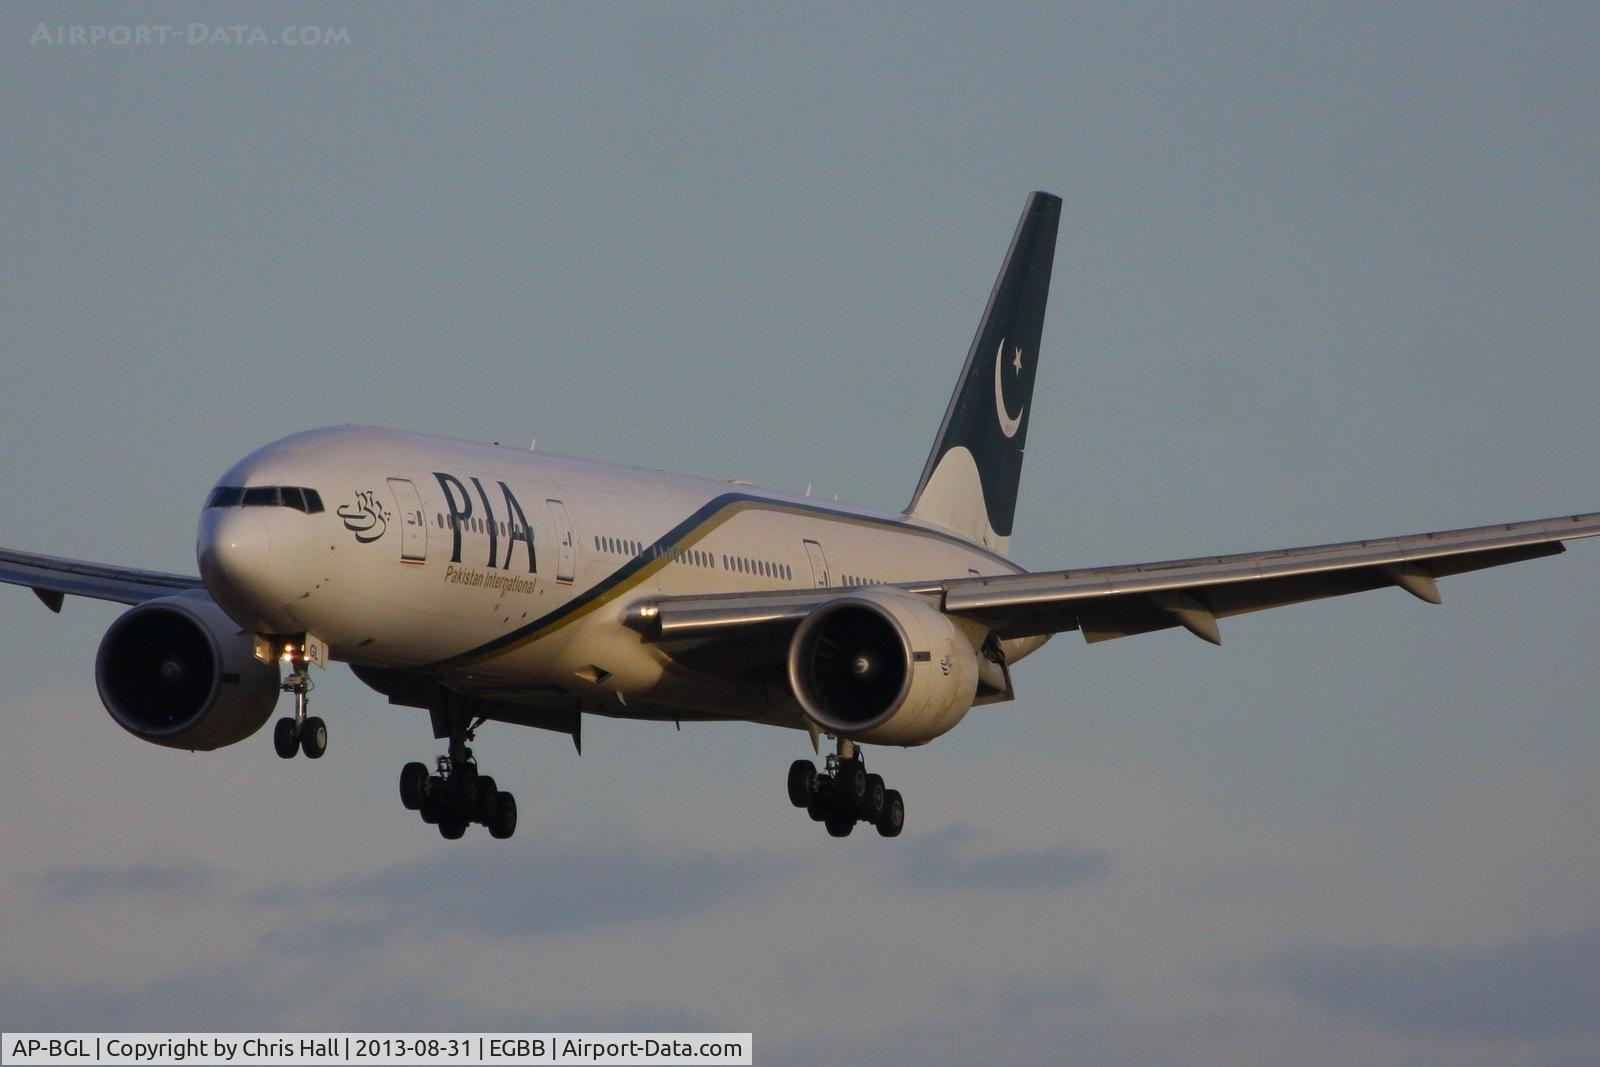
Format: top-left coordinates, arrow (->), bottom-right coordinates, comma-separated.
627,514 -> 1600,645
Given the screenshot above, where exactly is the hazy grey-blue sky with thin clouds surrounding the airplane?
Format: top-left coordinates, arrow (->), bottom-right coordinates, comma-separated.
0,5 -> 1600,1065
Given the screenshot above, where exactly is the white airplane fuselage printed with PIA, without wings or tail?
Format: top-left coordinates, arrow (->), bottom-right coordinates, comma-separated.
197,427 -> 1021,725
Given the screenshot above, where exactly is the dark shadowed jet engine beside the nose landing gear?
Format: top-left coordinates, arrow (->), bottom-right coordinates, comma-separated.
94,595 -> 278,750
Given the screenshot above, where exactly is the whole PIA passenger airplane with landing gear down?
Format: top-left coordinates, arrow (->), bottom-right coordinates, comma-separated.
0,192 -> 1600,840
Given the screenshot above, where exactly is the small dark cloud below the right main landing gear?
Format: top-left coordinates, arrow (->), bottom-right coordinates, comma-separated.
894,825 -> 1110,891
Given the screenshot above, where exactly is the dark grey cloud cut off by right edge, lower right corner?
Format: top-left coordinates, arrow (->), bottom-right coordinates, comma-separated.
1269,928 -> 1600,1040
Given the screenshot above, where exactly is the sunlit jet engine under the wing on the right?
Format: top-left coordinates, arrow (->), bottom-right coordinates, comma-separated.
789,589 -> 978,745
